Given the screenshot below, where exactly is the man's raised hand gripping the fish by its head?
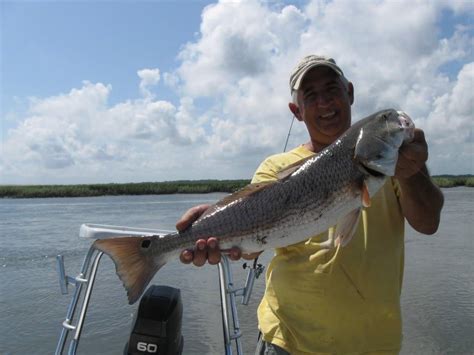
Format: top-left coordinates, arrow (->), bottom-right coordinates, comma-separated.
395,128 -> 428,179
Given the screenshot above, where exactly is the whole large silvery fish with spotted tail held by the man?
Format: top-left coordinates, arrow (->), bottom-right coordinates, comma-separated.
94,110 -> 414,303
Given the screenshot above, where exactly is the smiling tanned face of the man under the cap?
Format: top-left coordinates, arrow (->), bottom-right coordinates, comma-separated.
297,67 -> 353,146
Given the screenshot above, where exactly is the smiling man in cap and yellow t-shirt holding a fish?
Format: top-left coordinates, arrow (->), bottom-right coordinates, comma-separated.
177,55 -> 443,354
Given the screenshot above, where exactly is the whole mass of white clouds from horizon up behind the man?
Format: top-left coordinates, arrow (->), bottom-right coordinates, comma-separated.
0,0 -> 474,182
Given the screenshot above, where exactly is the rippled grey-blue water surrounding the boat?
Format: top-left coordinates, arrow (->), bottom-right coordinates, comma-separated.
0,188 -> 474,355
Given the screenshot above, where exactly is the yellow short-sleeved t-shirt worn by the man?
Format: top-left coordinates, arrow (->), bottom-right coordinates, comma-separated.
252,146 -> 404,354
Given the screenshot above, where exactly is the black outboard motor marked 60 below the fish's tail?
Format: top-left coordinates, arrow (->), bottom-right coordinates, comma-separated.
125,285 -> 183,355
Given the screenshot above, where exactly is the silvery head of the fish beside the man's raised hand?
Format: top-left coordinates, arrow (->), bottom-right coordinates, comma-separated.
354,109 -> 415,176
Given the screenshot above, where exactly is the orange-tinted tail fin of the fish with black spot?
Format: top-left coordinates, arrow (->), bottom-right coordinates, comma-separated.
94,237 -> 166,304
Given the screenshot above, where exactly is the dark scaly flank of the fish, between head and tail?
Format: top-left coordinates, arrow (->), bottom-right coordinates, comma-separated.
157,135 -> 364,252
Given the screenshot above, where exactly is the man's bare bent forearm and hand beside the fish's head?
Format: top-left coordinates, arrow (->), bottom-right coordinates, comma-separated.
395,129 -> 444,234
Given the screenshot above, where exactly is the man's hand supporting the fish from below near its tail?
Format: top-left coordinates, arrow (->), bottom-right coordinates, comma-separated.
176,205 -> 260,266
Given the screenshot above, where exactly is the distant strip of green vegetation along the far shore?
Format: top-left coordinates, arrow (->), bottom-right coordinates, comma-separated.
0,175 -> 474,198
